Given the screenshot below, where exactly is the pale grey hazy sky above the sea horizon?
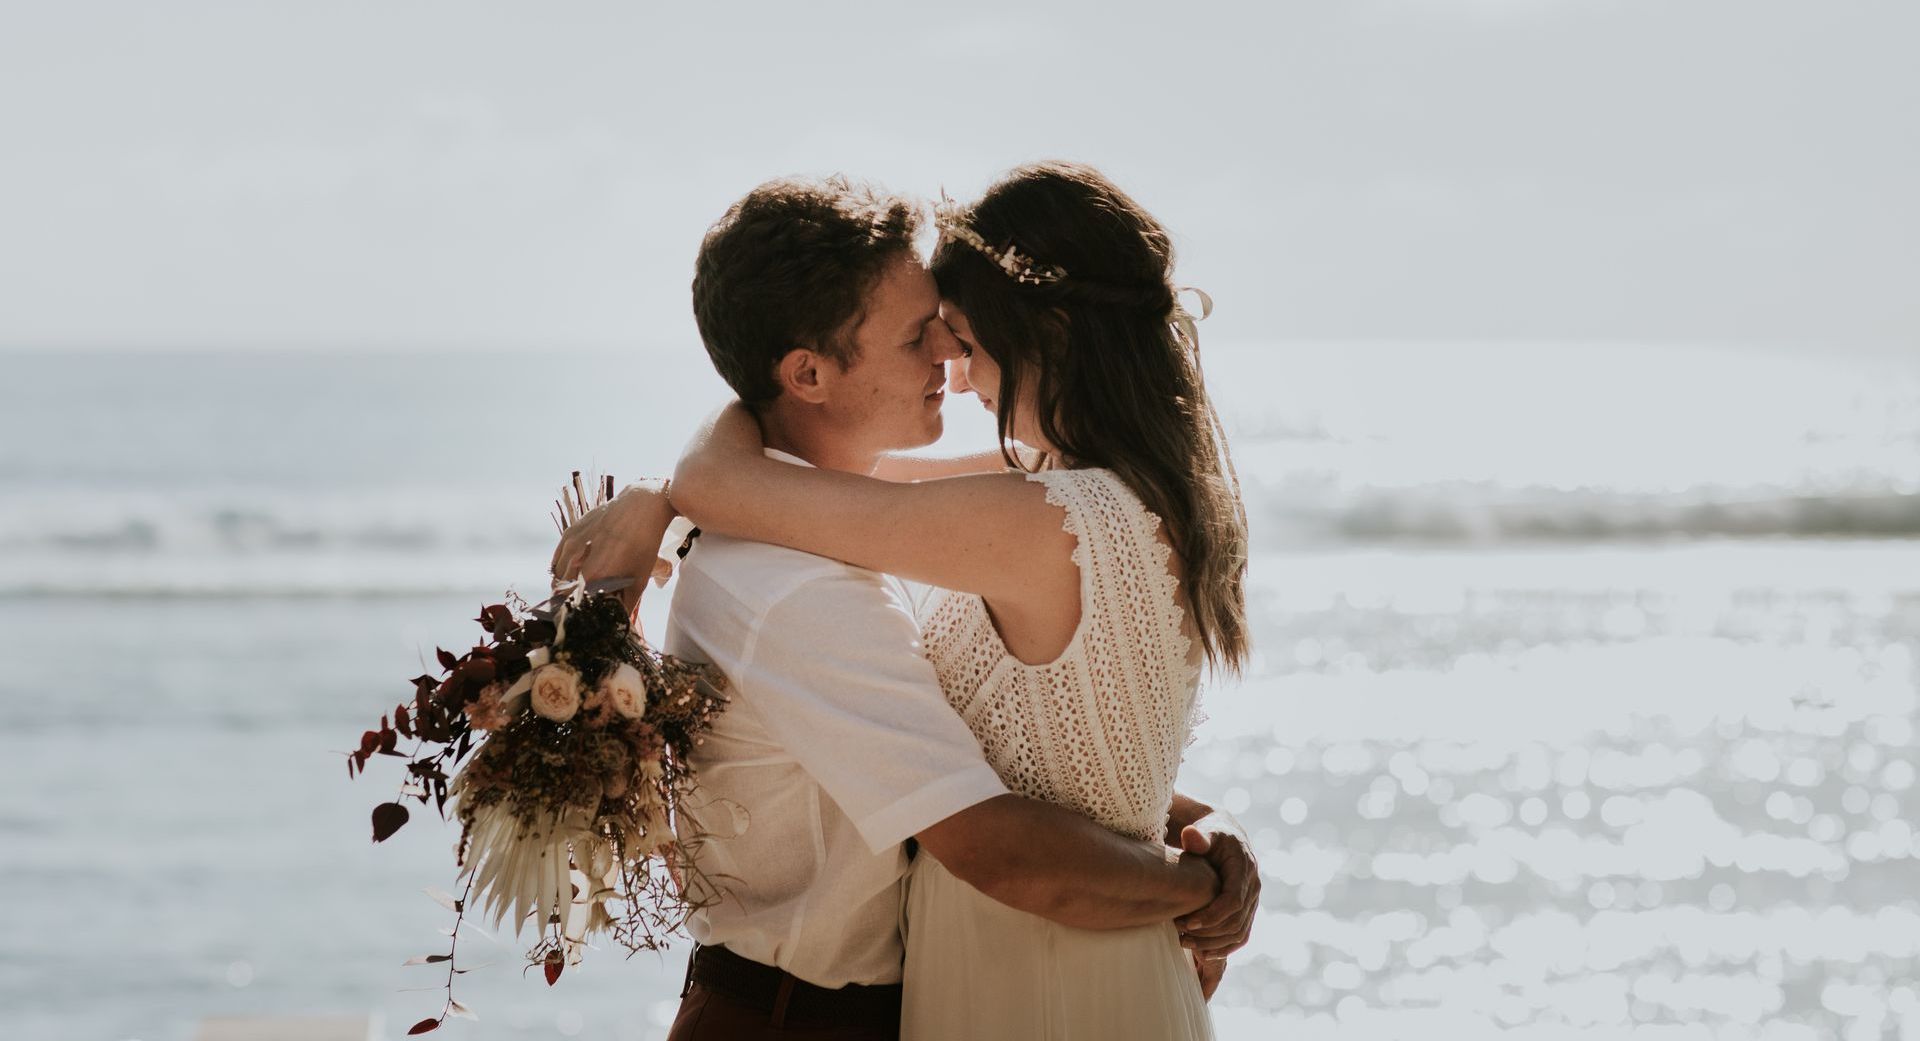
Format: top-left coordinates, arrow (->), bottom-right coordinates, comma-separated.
0,0 -> 1920,353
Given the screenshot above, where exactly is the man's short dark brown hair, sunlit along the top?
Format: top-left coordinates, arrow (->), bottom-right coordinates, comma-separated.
693,177 -> 920,407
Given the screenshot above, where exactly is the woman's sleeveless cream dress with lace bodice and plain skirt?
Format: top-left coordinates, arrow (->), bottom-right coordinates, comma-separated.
900,471 -> 1212,1041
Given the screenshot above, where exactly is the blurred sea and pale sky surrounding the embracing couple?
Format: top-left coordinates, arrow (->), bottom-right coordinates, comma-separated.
0,0 -> 1920,1041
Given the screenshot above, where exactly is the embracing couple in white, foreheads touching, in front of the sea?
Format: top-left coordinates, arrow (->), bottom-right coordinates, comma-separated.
555,163 -> 1260,1041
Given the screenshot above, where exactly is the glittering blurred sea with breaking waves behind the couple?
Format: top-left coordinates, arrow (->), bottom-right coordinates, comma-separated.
0,342 -> 1920,1041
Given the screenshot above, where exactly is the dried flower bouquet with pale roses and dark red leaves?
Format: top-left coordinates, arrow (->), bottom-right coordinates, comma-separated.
348,472 -> 726,1033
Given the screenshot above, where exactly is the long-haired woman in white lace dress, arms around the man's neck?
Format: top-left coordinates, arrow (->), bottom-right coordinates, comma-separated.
672,163 -> 1248,1039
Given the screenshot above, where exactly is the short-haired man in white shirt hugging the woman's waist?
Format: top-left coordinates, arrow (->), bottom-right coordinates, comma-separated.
555,179 -> 1258,1041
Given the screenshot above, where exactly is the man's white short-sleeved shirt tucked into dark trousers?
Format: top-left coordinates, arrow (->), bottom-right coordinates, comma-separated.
664,449 -> 1006,987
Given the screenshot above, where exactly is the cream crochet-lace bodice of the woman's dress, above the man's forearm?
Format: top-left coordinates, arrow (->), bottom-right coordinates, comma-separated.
922,471 -> 1200,839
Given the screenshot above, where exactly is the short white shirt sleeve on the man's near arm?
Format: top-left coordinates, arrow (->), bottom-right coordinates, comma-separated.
733,572 -> 1006,853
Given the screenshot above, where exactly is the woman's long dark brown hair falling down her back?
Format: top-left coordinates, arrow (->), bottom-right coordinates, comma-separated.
933,161 -> 1248,672
